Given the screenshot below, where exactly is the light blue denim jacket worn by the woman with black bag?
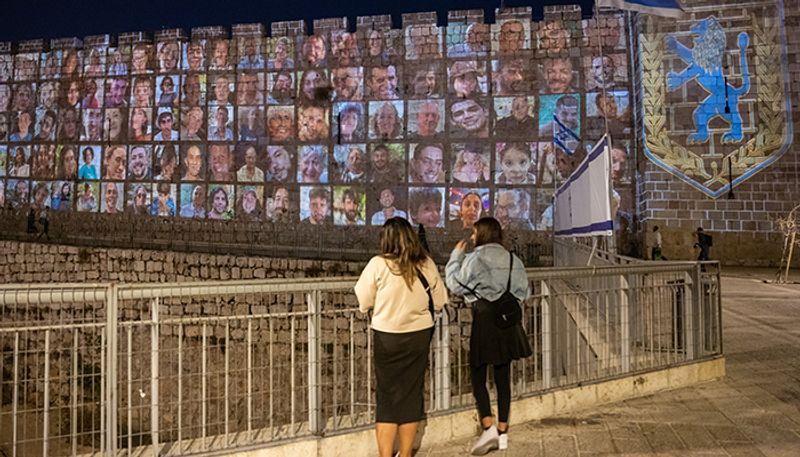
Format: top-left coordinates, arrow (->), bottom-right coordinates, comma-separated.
445,243 -> 530,302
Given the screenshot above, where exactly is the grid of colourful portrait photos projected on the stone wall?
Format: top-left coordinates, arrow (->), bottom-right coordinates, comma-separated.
0,11 -> 632,230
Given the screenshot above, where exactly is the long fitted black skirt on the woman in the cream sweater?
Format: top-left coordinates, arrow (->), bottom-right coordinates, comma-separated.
372,328 -> 433,424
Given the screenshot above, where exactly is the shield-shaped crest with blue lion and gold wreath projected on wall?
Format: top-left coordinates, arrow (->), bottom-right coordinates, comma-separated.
639,1 -> 792,198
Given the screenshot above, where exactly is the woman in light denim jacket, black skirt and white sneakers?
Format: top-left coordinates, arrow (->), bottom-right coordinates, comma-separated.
445,217 -> 532,455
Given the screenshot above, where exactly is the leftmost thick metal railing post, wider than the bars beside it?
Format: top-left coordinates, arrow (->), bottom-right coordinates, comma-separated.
103,284 -> 119,457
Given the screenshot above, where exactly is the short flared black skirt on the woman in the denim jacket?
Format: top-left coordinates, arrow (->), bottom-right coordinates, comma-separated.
469,300 -> 533,367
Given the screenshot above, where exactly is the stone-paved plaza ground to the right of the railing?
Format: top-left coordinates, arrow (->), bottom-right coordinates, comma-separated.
418,268 -> 800,457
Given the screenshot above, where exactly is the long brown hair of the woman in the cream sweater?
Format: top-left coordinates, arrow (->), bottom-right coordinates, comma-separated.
381,217 -> 427,289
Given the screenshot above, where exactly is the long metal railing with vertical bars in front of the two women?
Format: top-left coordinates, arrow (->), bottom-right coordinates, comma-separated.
0,262 -> 722,457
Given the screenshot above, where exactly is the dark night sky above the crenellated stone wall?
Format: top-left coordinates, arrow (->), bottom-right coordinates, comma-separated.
0,0 -> 594,41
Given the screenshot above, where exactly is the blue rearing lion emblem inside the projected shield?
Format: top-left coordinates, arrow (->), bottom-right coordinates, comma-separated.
666,16 -> 750,143
